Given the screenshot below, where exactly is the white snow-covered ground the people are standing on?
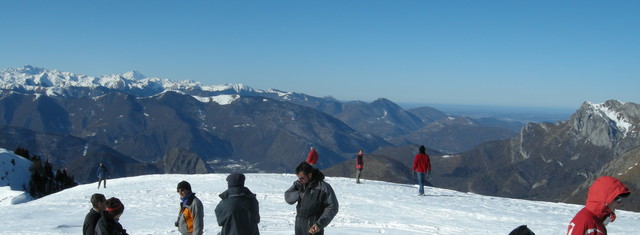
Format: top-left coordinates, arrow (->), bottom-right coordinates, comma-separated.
0,174 -> 640,235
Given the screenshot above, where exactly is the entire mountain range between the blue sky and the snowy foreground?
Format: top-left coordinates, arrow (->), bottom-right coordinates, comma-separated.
0,66 -> 640,212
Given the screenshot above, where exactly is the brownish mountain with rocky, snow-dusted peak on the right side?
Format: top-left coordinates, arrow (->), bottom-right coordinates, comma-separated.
327,100 -> 640,211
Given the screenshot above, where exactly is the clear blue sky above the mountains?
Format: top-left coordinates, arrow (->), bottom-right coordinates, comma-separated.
0,0 -> 640,108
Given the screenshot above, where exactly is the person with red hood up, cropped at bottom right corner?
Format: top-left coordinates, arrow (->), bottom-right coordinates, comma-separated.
567,176 -> 631,235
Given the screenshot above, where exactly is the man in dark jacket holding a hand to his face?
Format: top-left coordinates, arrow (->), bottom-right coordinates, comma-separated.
284,162 -> 339,235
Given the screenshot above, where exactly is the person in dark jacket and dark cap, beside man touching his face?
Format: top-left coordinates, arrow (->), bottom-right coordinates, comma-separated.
215,173 -> 260,235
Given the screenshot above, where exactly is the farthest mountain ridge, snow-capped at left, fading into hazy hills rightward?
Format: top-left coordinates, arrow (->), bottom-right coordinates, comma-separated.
0,65 -> 522,152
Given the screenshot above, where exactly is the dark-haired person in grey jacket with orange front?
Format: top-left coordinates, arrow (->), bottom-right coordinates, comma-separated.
175,181 -> 204,235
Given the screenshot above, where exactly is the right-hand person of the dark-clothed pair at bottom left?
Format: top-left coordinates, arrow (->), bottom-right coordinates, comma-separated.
95,197 -> 128,235
